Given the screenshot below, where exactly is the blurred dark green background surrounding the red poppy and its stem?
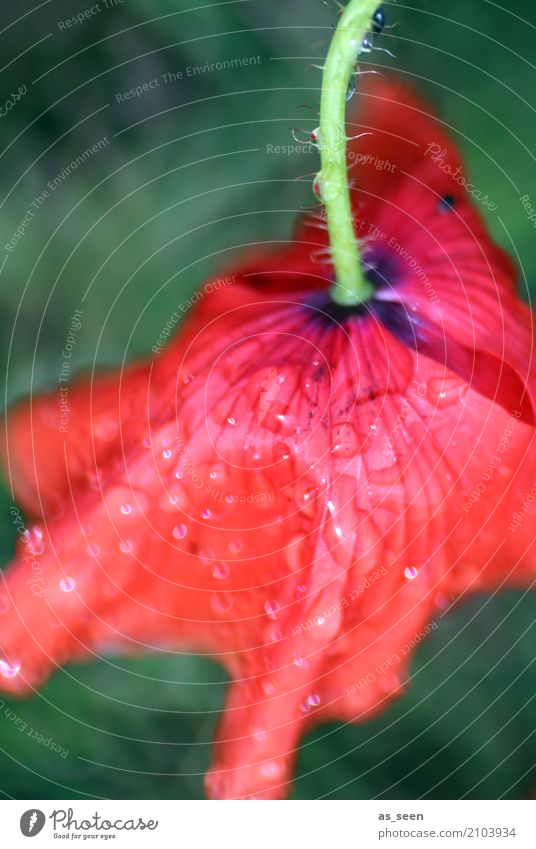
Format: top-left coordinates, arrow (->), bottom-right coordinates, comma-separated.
0,0 -> 536,798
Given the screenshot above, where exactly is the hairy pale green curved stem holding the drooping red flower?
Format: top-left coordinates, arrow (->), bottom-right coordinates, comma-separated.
316,0 -> 378,306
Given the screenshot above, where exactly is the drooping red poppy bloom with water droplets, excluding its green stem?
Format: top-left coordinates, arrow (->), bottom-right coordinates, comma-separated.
0,76 -> 536,798
